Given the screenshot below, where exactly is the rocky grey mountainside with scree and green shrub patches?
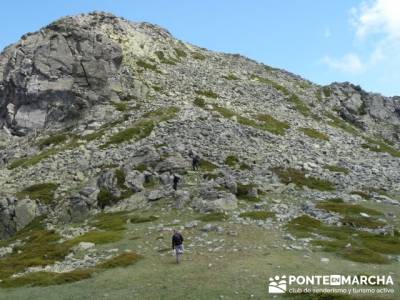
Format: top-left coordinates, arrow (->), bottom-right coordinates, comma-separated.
0,13 -> 400,296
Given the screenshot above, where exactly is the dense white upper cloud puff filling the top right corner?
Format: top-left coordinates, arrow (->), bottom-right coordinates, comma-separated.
351,0 -> 400,39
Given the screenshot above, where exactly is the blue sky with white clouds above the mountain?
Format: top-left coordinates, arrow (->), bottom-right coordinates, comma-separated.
0,0 -> 400,96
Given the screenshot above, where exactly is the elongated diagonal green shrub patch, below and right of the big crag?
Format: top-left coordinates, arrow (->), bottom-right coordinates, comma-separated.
101,119 -> 155,149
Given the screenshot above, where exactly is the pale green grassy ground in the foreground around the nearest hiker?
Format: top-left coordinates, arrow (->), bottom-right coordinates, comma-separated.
0,204 -> 399,300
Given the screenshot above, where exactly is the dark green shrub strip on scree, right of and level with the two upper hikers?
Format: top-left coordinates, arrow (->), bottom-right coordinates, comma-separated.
272,167 -> 335,191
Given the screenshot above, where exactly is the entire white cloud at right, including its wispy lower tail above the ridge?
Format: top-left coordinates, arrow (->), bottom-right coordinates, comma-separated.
322,0 -> 400,74
